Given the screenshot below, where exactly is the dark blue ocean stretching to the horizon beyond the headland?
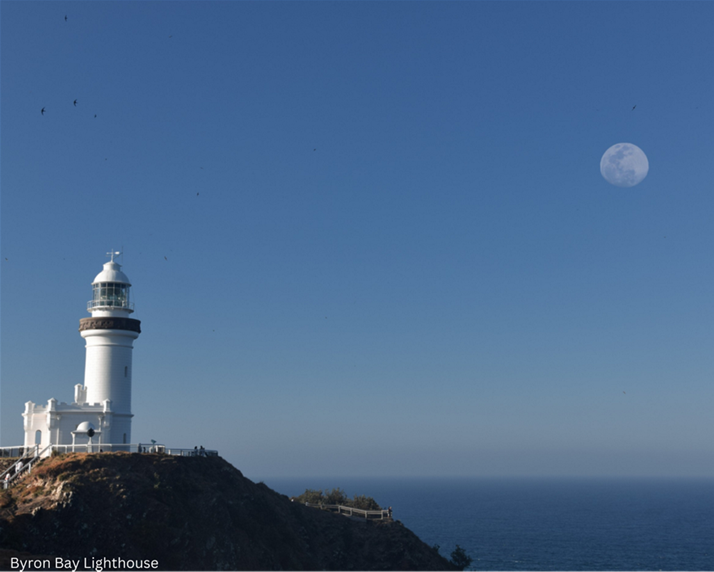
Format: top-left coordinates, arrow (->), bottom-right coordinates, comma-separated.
265,478 -> 714,572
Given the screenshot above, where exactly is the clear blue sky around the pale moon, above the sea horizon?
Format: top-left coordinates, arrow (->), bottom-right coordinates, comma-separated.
0,2 -> 714,478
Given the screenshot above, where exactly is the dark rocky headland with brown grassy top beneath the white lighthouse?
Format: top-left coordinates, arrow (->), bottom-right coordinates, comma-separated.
0,453 -> 456,572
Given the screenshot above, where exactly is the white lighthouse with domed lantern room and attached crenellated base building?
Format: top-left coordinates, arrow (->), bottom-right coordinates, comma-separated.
22,252 -> 141,450
